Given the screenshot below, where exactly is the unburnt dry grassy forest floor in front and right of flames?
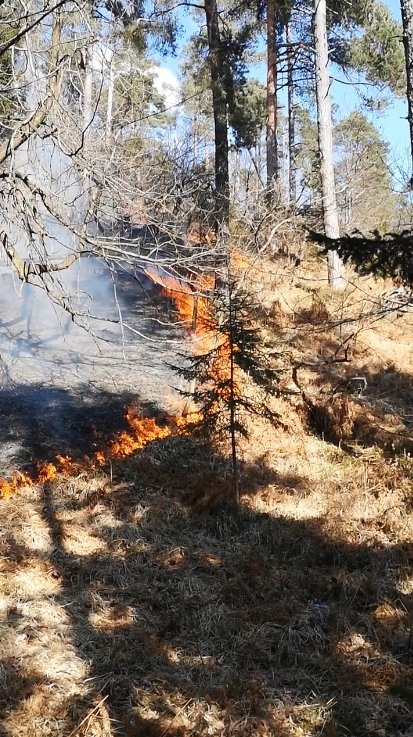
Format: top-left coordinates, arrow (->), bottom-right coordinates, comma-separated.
0,239 -> 413,737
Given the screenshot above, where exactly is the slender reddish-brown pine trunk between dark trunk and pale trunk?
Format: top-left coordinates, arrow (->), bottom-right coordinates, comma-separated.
267,0 -> 279,201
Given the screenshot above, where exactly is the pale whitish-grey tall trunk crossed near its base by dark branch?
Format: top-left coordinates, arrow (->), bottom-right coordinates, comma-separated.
314,0 -> 345,289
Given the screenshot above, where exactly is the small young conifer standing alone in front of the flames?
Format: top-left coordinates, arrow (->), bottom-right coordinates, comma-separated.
174,268 -> 280,504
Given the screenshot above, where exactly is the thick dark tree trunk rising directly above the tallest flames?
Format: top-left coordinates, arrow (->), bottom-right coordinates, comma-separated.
204,0 -> 229,228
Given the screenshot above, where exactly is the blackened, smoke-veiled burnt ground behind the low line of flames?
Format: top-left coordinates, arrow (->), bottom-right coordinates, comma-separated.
0,269 -> 182,474
